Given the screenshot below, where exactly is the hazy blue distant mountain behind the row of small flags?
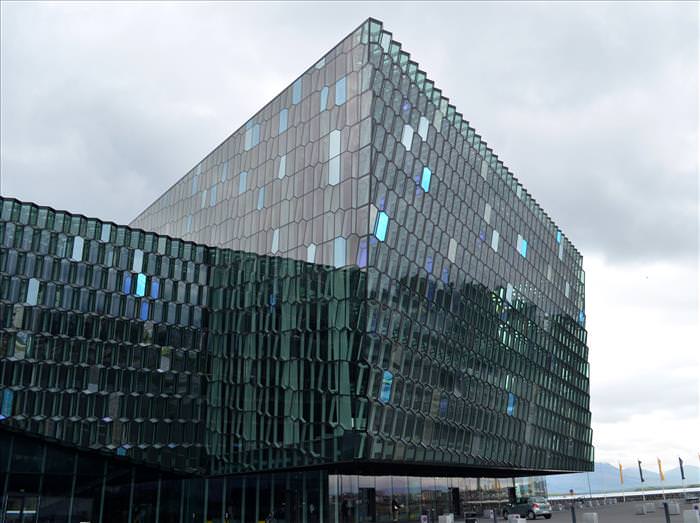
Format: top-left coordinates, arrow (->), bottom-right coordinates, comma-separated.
547,463 -> 700,495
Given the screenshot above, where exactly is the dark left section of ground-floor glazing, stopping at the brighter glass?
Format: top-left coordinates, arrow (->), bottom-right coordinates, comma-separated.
0,429 -> 328,523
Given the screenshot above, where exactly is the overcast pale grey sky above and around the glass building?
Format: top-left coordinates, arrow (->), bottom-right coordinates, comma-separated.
0,2 -> 700,467
